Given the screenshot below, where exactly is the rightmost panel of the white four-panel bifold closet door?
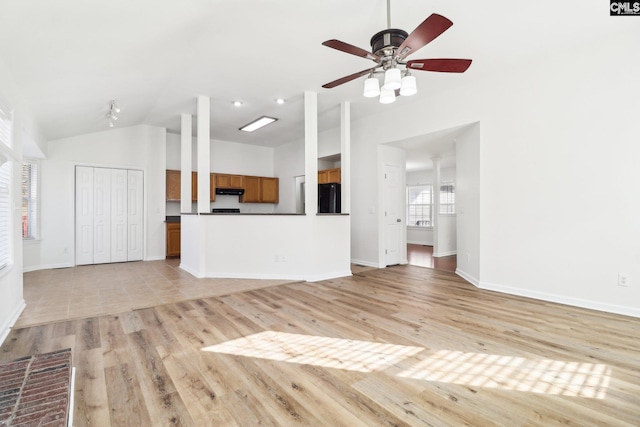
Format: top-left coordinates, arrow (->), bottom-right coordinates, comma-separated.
127,170 -> 144,261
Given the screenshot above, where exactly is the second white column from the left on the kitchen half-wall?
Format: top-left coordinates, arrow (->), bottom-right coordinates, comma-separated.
197,95 -> 211,213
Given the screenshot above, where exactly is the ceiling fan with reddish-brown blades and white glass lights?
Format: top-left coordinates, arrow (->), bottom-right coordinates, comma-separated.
322,0 -> 471,104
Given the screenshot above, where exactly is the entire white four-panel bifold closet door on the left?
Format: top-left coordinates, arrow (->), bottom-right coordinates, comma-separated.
76,166 -> 144,265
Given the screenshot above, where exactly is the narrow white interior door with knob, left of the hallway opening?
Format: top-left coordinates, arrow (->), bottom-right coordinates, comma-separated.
384,164 -> 404,265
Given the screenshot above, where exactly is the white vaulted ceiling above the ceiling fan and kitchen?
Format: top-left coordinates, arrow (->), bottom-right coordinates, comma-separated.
0,0 -> 637,152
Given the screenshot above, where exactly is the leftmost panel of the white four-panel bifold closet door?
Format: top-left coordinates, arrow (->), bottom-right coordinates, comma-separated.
76,166 -> 93,265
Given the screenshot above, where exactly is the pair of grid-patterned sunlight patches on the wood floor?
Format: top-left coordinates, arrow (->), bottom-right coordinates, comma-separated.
202,331 -> 611,399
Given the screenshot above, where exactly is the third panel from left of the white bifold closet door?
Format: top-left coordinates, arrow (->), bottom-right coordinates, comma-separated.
111,169 -> 128,262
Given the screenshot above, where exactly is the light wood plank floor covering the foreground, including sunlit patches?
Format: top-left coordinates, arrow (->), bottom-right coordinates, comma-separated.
0,266 -> 640,427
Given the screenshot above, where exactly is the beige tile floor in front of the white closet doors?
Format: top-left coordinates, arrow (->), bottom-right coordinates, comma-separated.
15,259 -> 298,328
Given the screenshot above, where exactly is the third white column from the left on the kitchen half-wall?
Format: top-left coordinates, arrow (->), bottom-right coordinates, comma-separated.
304,91 -> 318,215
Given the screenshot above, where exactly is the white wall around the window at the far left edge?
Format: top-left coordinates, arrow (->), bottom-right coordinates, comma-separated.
0,58 -> 44,344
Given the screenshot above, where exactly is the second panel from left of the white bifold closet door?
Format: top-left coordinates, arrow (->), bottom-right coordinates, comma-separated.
93,168 -> 111,264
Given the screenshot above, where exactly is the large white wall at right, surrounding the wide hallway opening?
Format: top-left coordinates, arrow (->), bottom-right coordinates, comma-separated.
352,21 -> 640,316
